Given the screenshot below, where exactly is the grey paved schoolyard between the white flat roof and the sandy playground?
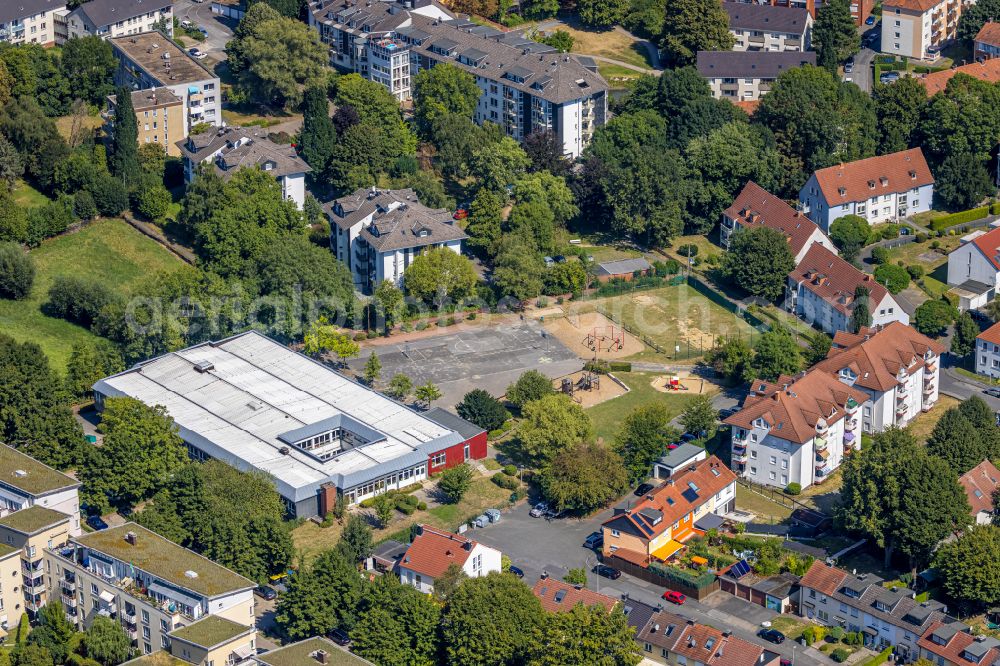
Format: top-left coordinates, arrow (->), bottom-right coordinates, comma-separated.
348,321 -> 583,408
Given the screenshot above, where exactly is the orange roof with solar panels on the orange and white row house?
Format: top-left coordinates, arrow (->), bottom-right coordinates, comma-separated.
603,456 -> 736,541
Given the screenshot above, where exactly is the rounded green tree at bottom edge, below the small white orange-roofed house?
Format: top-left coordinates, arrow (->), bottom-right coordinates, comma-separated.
441,573 -> 544,666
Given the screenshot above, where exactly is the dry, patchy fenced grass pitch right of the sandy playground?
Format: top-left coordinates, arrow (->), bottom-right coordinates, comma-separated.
581,284 -> 759,361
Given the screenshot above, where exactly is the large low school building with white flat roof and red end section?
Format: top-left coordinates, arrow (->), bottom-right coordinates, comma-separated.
94,331 -> 486,518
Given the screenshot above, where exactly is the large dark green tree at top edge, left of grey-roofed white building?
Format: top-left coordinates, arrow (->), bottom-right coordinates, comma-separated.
660,0 -> 736,66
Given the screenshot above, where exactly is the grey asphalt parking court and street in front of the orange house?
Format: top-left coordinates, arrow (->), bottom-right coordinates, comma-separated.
476,495 -> 832,666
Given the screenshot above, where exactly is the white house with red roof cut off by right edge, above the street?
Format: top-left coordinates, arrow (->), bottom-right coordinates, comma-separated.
948,223 -> 1000,312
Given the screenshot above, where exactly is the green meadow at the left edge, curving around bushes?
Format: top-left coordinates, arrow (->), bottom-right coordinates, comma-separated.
0,220 -> 186,372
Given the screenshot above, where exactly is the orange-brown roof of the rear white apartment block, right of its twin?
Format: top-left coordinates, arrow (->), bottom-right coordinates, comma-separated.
810,321 -> 944,391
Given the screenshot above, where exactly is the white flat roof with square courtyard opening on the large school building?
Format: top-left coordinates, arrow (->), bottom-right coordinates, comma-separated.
94,331 -> 463,501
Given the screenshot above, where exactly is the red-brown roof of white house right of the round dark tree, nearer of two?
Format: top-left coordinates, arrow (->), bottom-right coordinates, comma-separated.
788,243 -> 889,317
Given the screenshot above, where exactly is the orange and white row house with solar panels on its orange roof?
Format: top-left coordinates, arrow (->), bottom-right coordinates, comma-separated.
601,455 -> 736,566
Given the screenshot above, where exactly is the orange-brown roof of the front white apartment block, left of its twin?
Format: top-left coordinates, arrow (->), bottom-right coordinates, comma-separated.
724,370 -> 868,444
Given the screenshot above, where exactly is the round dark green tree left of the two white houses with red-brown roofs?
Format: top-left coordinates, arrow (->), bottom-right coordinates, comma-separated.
722,226 -> 795,301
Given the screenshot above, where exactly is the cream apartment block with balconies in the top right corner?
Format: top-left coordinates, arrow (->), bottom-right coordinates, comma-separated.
882,0 -> 965,59
